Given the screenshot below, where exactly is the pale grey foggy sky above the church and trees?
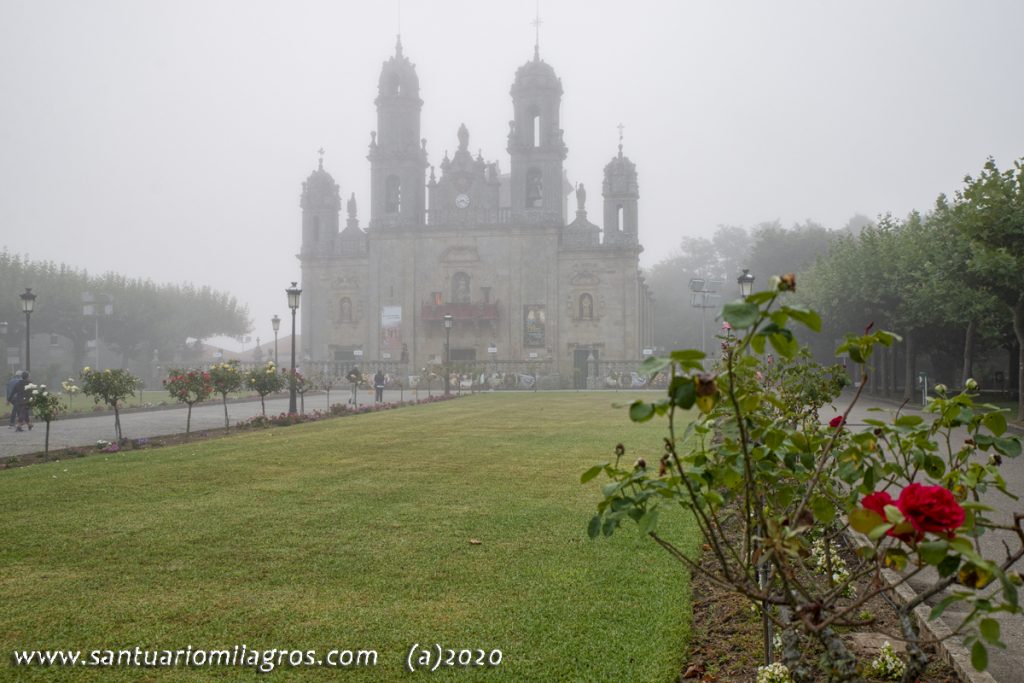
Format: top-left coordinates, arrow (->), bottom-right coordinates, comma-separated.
0,0 -> 1024,350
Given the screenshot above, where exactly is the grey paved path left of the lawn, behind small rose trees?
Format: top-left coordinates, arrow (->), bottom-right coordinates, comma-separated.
0,388 -> 443,458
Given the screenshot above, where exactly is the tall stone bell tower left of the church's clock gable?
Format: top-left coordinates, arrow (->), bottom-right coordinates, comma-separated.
367,36 -> 427,227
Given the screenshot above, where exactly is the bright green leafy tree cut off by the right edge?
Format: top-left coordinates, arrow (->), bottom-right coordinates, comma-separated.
952,158 -> 1024,420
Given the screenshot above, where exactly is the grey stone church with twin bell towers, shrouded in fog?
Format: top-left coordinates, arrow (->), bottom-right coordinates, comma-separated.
299,39 -> 652,387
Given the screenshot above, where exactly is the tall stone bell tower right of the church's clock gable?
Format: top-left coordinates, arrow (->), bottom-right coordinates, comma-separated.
508,47 -> 568,224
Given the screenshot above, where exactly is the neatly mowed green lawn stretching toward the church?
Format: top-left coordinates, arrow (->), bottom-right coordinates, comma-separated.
0,393 -> 696,681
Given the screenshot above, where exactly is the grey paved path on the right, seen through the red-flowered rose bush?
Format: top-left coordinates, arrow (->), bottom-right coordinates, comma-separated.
838,398 -> 1024,683
